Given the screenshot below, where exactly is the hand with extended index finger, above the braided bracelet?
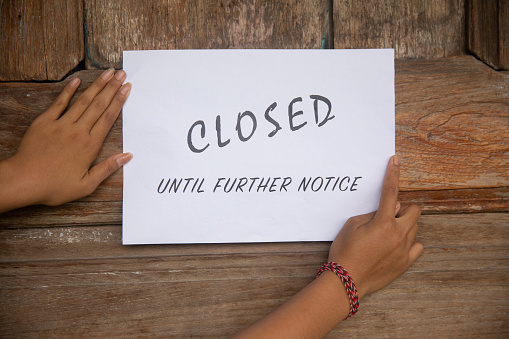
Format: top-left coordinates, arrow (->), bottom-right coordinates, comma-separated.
329,156 -> 423,298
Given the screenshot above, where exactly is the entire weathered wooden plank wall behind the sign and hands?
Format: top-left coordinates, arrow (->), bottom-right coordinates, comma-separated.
0,0 -> 509,338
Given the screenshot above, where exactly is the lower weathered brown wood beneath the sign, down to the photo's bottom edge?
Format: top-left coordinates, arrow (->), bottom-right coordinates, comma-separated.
0,213 -> 509,338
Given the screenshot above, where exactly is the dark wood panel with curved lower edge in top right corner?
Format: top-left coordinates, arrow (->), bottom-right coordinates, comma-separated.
466,0 -> 509,70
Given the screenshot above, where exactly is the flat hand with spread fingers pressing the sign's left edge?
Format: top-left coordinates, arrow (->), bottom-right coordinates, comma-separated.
0,69 -> 132,212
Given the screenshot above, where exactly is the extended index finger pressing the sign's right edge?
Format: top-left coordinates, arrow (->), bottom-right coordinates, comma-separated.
377,155 -> 399,218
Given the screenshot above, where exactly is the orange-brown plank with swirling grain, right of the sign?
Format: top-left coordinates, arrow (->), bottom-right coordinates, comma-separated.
396,57 -> 509,190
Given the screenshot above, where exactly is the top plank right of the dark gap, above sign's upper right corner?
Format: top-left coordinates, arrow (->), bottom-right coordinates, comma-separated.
333,0 -> 465,58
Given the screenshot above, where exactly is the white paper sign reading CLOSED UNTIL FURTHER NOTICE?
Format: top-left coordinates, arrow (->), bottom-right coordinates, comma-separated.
123,49 -> 395,244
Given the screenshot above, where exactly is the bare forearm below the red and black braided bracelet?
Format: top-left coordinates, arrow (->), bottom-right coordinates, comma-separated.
234,272 -> 350,338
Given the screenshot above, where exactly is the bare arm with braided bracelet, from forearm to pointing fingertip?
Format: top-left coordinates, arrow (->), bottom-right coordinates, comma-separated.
234,156 -> 423,338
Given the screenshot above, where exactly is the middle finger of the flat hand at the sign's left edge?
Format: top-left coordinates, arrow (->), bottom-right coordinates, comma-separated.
78,70 -> 126,129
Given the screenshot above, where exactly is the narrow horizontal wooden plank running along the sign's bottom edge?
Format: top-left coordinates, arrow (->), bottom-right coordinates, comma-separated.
0,213 -> 509,262
